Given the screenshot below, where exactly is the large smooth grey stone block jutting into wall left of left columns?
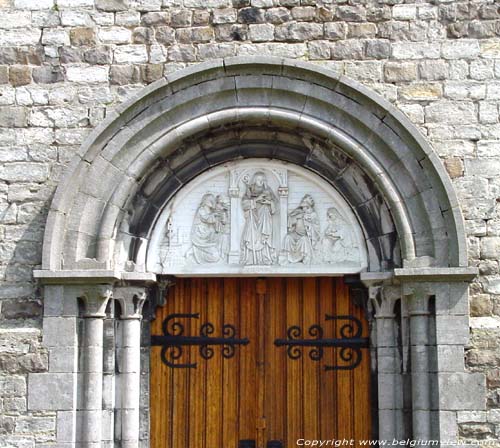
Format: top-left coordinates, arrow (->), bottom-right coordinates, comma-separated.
28,373 -> 76,411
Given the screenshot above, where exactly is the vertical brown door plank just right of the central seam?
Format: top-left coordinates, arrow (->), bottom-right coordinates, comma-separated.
264,278 -> 286,440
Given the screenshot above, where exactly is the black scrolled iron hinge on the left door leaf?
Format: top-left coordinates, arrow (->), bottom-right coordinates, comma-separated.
151,313 -> 250,369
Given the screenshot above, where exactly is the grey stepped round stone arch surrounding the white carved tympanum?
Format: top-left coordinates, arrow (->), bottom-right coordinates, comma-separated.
43,57 -> 467,271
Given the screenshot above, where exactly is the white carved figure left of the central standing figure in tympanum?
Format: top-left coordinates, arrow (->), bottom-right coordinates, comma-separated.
186,193 -> 227,264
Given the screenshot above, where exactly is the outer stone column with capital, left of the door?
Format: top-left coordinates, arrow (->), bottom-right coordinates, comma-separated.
79,285 -> 112,448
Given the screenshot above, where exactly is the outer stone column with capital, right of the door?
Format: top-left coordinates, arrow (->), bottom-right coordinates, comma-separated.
407,285 -> 433,440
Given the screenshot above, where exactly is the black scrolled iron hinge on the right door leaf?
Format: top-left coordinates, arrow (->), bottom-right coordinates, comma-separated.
274,314 -> 369,371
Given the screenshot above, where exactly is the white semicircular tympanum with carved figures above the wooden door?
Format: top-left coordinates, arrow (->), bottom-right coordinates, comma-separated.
148,159 -> 366,275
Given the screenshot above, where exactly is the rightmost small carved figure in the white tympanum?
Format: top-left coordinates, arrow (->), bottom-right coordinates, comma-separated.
321,207 -> 356,263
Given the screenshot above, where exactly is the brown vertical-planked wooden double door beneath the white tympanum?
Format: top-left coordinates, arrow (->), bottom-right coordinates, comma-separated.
150,277 -> 372,448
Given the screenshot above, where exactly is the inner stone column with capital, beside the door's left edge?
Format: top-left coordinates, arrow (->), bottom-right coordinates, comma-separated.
114,286 -> 146,448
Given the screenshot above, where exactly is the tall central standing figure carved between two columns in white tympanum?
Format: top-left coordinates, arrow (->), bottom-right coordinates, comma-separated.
240,171 -> 278,265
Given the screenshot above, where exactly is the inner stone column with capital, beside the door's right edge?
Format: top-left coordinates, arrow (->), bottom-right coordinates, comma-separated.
369,286 -> 403,442
